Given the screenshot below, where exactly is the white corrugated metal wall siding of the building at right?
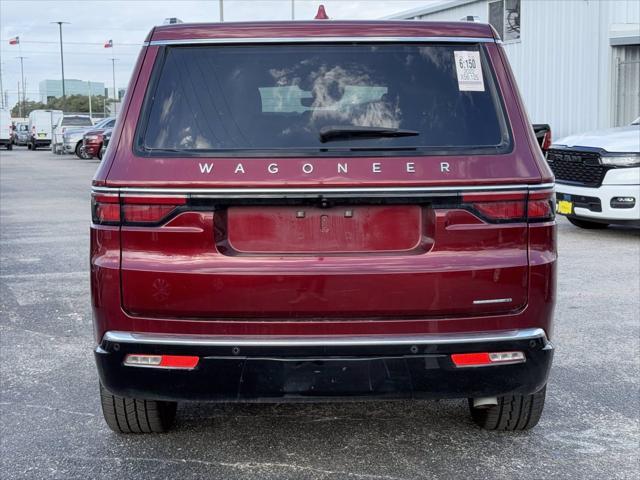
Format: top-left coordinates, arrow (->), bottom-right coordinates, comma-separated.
408,0 -> 640,139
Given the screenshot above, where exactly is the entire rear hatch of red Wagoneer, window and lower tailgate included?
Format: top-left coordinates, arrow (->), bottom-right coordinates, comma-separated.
101,42 -> 552,320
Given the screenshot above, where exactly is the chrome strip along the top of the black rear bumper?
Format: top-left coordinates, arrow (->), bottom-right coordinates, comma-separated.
102,328 -> 547,347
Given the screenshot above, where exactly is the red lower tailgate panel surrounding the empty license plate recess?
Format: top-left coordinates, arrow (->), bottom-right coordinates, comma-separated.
122,212 -> 527,319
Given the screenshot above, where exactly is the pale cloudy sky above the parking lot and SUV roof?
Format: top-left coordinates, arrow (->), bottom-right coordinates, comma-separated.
0,0 -> 439,105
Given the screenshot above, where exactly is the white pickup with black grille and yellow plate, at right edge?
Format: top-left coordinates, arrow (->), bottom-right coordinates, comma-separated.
547,118 -> 640,229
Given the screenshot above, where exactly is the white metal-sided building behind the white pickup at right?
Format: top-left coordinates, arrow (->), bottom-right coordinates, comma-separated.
388,0 -> 640,138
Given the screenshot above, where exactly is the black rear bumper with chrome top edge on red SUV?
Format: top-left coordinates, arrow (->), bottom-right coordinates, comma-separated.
95,328 -> 553,401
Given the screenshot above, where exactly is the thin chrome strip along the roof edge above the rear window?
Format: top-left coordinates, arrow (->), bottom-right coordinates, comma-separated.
143,36 -> 495,46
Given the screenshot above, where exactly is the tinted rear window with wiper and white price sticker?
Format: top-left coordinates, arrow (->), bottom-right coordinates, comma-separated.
137,44 -> 510,156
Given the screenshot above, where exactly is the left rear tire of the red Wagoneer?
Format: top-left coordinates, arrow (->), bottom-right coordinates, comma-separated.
100,384 -> 177,433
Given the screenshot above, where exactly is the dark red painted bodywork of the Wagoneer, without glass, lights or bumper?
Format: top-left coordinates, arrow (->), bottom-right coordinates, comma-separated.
91,22 -> 556,348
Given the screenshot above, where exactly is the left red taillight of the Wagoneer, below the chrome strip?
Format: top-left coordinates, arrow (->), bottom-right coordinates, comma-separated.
92,193 -> 187,226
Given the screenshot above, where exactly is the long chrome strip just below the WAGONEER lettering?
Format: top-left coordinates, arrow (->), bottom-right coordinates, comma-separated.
92,183 -> 555,198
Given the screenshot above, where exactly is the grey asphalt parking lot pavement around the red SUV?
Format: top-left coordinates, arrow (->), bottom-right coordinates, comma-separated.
0,148 -> 640,480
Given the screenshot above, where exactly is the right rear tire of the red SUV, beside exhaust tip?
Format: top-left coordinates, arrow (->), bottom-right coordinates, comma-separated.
469,385 -> 547,431
